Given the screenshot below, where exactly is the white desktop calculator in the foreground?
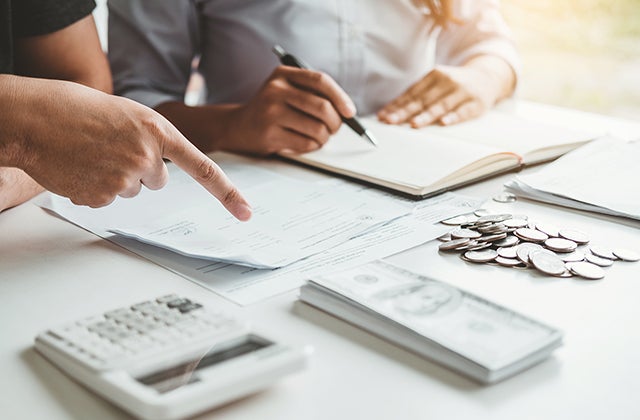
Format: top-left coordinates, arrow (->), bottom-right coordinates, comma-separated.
35,295 -> 310,419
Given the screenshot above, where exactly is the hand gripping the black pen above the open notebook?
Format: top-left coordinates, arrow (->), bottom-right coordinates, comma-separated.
223,66 -> 356,154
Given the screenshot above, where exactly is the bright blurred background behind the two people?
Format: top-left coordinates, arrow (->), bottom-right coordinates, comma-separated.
96,0 -> 640,120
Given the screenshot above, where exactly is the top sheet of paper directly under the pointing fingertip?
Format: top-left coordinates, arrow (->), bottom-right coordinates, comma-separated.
42,161 -> 411,268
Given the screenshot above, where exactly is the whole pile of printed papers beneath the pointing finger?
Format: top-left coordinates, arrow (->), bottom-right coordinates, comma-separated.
37,153 -> 482,305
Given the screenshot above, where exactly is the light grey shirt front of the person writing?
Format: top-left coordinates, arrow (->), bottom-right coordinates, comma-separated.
192,0 -> 434,114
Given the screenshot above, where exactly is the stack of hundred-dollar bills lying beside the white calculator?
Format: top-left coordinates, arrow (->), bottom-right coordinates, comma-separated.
300,261 -> 562,383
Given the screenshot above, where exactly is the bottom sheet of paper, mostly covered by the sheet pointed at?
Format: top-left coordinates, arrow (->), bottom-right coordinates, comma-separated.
39,155 -> 481,305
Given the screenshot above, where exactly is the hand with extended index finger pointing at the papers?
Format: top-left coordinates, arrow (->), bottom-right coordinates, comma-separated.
5,78 -> 251,220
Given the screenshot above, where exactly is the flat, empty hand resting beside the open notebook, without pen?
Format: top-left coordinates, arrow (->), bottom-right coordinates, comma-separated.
378,57 -> 515,128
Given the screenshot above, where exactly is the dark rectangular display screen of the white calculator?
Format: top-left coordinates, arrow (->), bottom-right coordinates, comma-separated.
136,335 -> 273,393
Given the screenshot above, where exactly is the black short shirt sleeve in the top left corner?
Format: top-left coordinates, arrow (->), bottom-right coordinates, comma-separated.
12,0 -> 96,38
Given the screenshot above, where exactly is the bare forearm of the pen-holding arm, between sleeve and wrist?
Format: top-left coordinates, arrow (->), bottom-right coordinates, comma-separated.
156,102 -> 240,152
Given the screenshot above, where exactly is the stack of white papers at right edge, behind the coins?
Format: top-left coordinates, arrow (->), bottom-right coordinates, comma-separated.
505,137 -> 640,220
